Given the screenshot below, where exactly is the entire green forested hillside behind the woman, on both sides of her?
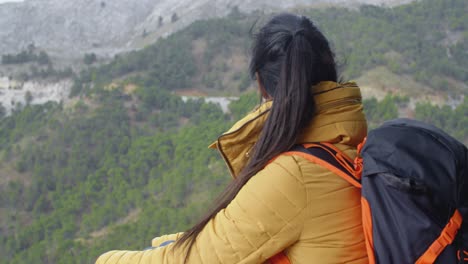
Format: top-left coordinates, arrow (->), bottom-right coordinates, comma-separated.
0,0 -> 468,263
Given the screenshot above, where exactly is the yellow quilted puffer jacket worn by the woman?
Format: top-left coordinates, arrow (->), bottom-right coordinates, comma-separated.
96,82 -> 368,264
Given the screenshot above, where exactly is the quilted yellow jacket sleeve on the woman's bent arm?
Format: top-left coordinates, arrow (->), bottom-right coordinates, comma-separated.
96,156 -> 307,264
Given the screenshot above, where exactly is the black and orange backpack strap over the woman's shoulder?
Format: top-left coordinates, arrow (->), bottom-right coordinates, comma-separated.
282,143 -> 361,188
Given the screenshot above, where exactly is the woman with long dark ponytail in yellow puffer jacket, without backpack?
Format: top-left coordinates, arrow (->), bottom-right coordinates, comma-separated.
97,14 -> 368,264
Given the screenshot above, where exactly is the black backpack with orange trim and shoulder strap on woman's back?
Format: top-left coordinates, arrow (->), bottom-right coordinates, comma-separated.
272,119 -> 468,264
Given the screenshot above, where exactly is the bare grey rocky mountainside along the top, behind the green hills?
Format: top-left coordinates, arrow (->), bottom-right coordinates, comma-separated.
0,0 -> 409,58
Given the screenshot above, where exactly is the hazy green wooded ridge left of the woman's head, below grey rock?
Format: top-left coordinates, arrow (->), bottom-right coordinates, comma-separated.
71,11 -> 254,97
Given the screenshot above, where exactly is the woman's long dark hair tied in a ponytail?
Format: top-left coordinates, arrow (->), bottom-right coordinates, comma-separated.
177,14 -> 337,262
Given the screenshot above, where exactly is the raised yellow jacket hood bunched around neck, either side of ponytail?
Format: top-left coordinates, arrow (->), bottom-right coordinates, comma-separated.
210,82 -> 367,177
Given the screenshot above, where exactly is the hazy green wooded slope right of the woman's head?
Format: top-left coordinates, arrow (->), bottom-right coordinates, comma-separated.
306,0 -> 468,91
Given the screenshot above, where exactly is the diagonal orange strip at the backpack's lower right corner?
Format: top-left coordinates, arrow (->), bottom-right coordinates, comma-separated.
416,210 -> 463,264
